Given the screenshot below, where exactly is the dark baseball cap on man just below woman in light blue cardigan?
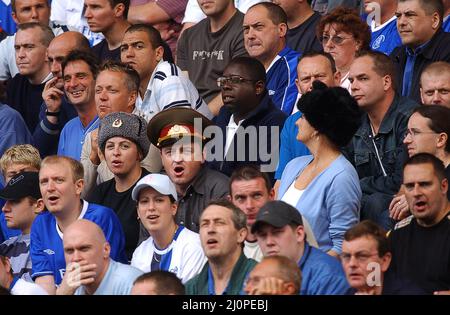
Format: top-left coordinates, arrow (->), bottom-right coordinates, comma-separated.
252,200 -> 303,234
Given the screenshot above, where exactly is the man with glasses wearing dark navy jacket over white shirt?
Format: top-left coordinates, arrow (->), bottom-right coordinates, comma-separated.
210,57 -> 286,181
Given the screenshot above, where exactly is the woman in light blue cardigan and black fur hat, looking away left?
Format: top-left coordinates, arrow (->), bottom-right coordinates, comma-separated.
278,81 -> 362,256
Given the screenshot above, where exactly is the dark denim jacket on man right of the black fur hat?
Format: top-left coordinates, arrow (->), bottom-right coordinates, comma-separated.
345,95 -> 418,195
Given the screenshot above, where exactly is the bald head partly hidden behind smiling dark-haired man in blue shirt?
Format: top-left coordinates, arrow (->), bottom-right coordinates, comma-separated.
47,31 -> 90,83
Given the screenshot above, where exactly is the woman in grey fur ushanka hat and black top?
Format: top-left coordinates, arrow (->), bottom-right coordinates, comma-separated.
87,112 -> 150,259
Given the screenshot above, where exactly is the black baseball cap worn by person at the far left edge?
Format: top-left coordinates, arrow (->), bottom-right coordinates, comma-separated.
0,172 -> 42,200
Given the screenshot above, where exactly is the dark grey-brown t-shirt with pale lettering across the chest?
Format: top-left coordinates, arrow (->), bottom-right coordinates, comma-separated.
177,11 -> 247,103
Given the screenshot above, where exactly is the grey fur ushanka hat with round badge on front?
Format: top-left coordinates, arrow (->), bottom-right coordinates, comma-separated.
98,112 -> 150,159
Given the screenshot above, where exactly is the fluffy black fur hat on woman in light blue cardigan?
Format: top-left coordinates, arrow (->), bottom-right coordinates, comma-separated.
297,81 -> 362,148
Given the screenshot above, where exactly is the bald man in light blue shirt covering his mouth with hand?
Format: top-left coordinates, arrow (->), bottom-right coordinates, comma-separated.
56,219 -> 143,295
